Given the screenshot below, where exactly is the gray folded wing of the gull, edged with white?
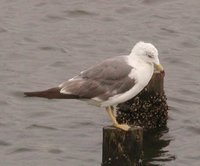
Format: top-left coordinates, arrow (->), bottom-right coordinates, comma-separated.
60,56 -> 135,100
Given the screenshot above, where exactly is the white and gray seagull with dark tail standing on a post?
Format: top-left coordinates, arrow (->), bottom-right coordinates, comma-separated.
24,41 -> 164,131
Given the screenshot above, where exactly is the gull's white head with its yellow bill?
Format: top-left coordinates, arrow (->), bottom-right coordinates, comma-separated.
131,41 -> 163,71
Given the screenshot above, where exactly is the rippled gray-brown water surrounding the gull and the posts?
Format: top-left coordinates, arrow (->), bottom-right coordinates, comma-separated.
0,0 -> 200,166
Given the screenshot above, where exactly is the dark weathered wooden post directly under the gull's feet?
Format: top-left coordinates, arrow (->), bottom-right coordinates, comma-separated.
102,126 -> 143,166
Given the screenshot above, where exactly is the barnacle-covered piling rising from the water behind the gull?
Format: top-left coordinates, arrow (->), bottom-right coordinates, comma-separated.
117,73 -> 168,130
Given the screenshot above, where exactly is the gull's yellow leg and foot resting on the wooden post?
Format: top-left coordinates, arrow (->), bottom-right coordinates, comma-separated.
106,106 -> 130,131
